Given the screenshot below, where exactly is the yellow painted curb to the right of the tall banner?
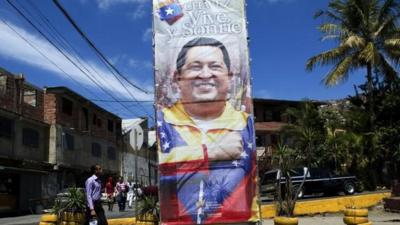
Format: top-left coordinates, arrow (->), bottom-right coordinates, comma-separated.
261,192 -> 390,219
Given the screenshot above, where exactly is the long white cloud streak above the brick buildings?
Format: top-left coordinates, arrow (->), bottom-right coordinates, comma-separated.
0,19 -> 153,100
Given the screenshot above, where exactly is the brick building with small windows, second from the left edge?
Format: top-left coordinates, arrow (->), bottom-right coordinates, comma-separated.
44,87 -> 122,188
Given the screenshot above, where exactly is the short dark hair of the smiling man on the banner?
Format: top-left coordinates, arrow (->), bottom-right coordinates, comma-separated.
176,37 -> 231,73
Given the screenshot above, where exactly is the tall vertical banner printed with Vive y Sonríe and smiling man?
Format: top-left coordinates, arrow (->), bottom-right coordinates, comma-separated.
153,0 -> 260,225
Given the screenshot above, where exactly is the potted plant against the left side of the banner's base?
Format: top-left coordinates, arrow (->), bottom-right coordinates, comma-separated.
137,186 -> 160,224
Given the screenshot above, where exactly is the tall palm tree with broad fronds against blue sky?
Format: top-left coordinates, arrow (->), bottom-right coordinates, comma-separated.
306,0 -> 400,123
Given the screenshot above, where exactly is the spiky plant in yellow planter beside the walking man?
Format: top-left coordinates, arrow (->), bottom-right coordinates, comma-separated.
53,187 -> 86,225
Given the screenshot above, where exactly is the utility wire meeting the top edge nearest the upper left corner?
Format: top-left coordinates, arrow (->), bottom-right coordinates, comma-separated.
7,0 -> 139,117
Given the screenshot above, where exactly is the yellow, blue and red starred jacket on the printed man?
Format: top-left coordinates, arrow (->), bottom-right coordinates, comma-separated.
157,102 -> 260,225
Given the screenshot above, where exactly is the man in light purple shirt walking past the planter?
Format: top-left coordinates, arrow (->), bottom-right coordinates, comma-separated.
85,164 -> 108,225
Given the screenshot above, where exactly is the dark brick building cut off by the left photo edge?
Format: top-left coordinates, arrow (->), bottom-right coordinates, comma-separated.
0,69 -> 52,212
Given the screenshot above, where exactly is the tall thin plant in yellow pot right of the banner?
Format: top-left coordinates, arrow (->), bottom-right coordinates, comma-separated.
274,144 -> 308,225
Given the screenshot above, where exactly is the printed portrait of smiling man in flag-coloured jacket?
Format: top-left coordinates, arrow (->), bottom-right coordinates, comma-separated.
157,37 -> 258,224
